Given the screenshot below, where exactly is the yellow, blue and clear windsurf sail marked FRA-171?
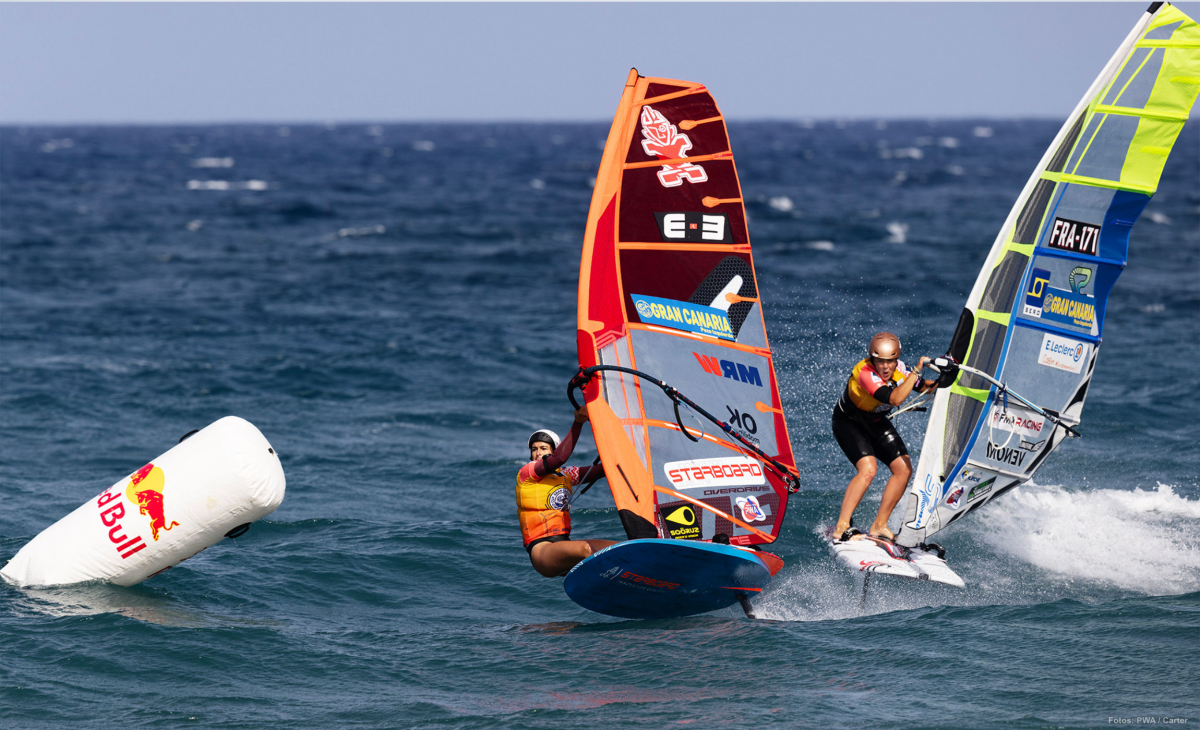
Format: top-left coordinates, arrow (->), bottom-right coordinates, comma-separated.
898,4 -> 1200,546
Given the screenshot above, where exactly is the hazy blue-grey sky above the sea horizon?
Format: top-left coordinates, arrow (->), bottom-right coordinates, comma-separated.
0,0 -> 1200,124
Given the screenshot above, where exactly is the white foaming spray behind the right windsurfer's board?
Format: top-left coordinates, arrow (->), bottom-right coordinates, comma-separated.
971,484 -> 1200,596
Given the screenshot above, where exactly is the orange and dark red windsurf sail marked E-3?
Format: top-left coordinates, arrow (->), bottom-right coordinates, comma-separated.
577,71 -> 796,544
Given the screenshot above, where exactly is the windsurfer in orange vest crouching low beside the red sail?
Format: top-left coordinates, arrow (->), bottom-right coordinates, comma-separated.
517,405 -> 614,578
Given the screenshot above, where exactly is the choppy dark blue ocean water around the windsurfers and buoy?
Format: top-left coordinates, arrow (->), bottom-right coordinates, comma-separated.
0,120 -> 1200,730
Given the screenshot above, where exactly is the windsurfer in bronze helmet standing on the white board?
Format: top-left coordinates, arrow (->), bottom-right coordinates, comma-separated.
833,333 -> 937,540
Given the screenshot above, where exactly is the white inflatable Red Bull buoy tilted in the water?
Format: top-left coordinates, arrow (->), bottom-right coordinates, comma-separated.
0,415 -> 284,586
